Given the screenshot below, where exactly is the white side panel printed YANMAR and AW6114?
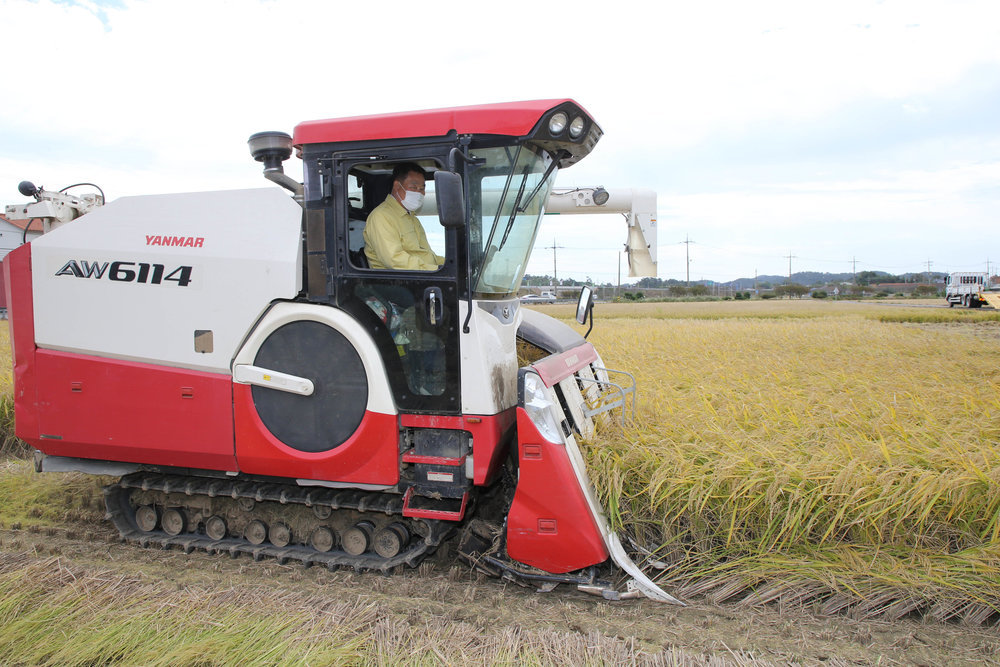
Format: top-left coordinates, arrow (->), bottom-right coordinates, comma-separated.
32,187 -> 302,374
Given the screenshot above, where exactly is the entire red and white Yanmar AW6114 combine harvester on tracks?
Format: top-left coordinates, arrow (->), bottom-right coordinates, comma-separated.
4,100 -> 676,602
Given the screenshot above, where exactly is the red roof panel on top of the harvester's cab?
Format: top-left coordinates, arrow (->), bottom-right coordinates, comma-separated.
293,99 -> 579,146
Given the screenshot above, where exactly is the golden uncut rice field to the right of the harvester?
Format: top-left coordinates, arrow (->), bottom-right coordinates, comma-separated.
572,301 -> 1000,623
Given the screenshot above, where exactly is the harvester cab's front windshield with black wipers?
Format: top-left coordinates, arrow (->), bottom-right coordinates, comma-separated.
469,146 -> 558,296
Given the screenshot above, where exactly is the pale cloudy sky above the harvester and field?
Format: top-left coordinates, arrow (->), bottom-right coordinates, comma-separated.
0,0 -> 1000,283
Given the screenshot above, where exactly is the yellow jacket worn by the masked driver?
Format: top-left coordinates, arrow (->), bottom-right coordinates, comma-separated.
364,194 -> 444,271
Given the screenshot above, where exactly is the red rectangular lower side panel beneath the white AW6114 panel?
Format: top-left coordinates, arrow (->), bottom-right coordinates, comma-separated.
30,350 -> 236,470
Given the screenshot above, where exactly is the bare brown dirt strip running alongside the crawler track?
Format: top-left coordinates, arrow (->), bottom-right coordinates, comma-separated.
0,512 -> 1000,665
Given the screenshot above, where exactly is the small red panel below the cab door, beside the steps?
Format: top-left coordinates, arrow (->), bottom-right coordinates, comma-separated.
399,408 -> 515,486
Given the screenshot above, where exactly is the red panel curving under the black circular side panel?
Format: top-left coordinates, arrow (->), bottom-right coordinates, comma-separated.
233,384 -> 399,486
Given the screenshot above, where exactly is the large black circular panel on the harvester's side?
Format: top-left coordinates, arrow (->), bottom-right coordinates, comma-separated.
252,320 -> 368,452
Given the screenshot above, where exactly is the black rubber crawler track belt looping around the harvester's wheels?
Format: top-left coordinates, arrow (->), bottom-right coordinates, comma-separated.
104,473 -> 456,572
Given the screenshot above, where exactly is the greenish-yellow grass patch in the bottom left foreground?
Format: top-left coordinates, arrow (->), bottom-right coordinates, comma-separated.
0,555 -> 375,666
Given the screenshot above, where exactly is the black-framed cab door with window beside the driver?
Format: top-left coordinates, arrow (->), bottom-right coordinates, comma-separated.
332,147 -> 462,414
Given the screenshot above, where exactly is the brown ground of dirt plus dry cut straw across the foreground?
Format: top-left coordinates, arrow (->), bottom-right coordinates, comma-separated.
0,468 -> 1000,665
